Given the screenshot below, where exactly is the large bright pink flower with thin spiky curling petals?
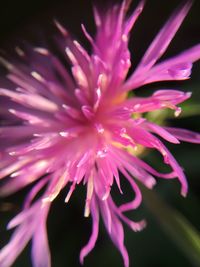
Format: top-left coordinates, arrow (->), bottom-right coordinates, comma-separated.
0,1 -> 200,267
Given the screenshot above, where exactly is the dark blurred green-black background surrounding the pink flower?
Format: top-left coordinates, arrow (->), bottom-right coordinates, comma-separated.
0,0 -> 200,267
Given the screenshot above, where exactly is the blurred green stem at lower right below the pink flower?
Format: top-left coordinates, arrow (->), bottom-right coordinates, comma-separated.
140,185 -> 200,267
